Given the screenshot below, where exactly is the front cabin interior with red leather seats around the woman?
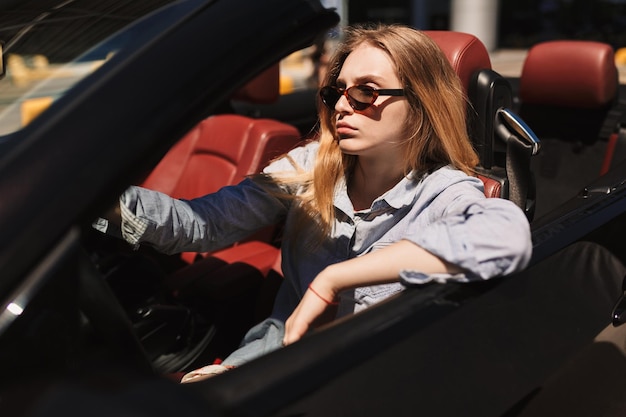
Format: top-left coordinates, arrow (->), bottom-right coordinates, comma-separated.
88,31 -> 538,378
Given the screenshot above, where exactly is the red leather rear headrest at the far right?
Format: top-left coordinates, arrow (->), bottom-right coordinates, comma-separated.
519,40 -> 619,144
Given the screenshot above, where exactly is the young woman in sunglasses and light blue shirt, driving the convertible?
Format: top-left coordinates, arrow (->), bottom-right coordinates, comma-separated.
111,22 -> 531,382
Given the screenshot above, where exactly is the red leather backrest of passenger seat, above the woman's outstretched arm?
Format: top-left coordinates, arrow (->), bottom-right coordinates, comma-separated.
143,114 -> 300,199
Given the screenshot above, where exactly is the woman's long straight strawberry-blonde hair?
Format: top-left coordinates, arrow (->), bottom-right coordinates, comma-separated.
268,25 -> 478,236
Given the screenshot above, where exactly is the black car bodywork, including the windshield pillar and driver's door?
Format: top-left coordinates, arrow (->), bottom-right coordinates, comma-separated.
0,0 -> 626,416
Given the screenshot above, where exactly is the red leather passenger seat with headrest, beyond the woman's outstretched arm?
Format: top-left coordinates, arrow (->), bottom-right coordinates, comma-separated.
142,65 -> 301,266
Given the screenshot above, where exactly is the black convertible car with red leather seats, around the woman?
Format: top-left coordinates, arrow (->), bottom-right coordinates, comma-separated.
0,0 -> 626,417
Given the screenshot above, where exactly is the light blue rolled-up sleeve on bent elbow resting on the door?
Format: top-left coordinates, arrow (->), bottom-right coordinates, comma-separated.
401,174 -> 532,281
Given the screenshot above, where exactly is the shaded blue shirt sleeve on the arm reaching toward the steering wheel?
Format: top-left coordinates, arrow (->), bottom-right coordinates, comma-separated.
120,179 -> 287,254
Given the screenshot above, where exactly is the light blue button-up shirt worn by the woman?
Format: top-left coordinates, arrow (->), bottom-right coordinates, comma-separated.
121,142 -> 532,320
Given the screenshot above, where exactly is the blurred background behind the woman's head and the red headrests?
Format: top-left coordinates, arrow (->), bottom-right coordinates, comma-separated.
281,0 -> 626,93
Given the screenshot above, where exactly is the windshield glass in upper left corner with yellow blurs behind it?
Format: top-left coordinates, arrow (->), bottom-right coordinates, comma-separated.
0,0 -> 177,135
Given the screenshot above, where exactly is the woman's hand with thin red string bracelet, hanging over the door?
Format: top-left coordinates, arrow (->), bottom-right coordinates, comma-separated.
283,279 -> 338,345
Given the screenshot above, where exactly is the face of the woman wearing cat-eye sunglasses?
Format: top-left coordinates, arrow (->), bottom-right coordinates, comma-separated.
335,43 -> 409,161
